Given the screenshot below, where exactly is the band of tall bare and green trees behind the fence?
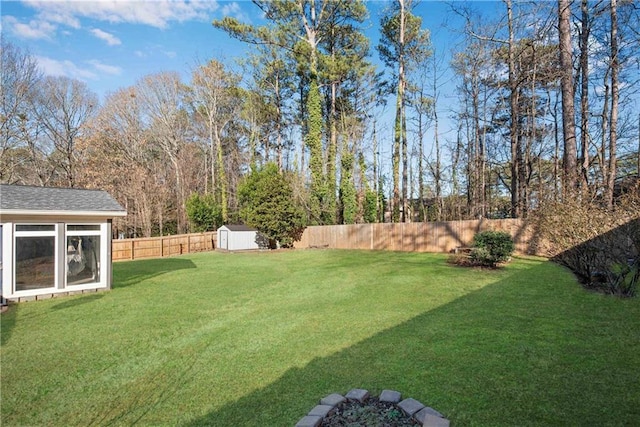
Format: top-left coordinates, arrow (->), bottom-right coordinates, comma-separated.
0,0 -> 640,237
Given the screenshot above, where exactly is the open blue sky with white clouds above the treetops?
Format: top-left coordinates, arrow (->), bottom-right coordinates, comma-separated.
2,0 -> 501,99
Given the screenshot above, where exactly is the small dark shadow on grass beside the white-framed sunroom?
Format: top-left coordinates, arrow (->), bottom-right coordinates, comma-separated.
113,257 -> 197,289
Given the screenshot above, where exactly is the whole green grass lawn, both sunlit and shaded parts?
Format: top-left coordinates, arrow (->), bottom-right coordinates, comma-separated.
0,250 -> 640,426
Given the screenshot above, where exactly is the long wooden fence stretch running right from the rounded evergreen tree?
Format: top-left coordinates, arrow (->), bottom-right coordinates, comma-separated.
294,219 -> 535,253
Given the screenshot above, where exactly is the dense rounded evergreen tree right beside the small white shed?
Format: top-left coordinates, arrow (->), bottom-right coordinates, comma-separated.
238,163 -> 305,248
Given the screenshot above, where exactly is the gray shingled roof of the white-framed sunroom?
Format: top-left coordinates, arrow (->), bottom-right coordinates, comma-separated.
0,184 -> 126,213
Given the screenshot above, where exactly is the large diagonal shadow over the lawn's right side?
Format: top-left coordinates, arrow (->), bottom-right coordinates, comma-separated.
182,263 -> 640,427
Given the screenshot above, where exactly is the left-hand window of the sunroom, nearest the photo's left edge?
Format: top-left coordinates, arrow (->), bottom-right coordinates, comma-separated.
15,225 -> 56,291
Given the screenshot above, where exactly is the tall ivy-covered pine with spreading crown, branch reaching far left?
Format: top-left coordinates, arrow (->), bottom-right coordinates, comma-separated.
213,0 -> 371,224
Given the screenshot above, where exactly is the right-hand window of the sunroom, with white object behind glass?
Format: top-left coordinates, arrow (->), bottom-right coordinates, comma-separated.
66,224 -> 102,286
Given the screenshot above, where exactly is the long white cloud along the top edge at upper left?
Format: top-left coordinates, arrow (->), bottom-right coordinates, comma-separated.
25,0 -> 218,28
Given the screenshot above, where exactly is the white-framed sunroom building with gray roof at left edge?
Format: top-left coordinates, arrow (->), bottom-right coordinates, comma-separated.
0,184 -> 127,301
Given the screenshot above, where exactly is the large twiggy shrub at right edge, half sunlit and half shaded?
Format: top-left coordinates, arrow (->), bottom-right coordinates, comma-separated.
534,187 -> 640,297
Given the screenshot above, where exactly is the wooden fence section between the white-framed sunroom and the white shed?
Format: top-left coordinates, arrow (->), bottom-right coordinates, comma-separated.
111,232 -> 216,261
